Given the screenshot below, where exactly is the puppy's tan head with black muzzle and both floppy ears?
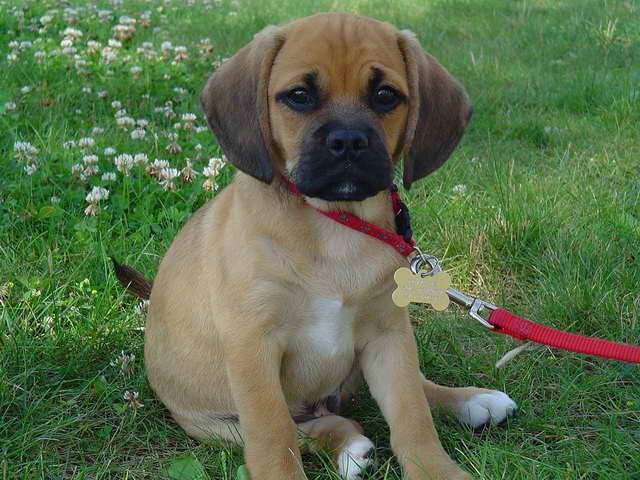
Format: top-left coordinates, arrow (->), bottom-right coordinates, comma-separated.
202,13 -> 473,201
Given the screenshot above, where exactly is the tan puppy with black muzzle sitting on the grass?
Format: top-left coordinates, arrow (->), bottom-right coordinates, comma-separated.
118,13 -> 515,480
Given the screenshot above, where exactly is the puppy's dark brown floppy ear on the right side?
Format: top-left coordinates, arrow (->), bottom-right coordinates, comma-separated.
398,30 -> 473,189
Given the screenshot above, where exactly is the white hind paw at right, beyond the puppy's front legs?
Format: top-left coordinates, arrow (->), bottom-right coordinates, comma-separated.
456,391 -> 518,428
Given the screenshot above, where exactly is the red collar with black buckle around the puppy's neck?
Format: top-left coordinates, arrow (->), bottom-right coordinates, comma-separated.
282,175 -> 416,257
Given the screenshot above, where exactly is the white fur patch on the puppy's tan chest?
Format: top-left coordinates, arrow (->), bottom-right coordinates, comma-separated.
305,297 -> 356,356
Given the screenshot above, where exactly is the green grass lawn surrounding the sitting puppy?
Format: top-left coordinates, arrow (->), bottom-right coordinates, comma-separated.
0,0 -> 640,480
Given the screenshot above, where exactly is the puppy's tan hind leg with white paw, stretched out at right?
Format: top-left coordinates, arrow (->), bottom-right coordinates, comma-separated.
422,378 -> 518,428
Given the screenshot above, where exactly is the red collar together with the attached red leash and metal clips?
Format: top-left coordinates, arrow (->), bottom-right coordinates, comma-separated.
282,175 -> 640,363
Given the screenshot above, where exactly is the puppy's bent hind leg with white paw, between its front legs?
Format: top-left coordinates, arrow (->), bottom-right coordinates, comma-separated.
298,415 -> 374,480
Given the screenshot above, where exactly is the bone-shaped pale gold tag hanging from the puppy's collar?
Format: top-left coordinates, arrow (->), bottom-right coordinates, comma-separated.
391,267 -> 451,311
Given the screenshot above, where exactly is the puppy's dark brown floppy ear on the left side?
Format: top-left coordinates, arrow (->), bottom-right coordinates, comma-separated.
200,26 -> 284,183
